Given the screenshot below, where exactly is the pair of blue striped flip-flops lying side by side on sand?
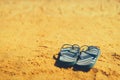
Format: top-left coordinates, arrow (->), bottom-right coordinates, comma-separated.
54,44 -> 100,69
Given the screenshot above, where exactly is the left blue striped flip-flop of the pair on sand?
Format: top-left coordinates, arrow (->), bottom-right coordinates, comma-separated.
57,44 -> 80,67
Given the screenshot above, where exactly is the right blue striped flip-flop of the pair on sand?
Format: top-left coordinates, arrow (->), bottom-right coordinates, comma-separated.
75,46 -> 100,69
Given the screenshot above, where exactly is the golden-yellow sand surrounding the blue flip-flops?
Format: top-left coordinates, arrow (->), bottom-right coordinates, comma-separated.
0,0 -> 120,80
